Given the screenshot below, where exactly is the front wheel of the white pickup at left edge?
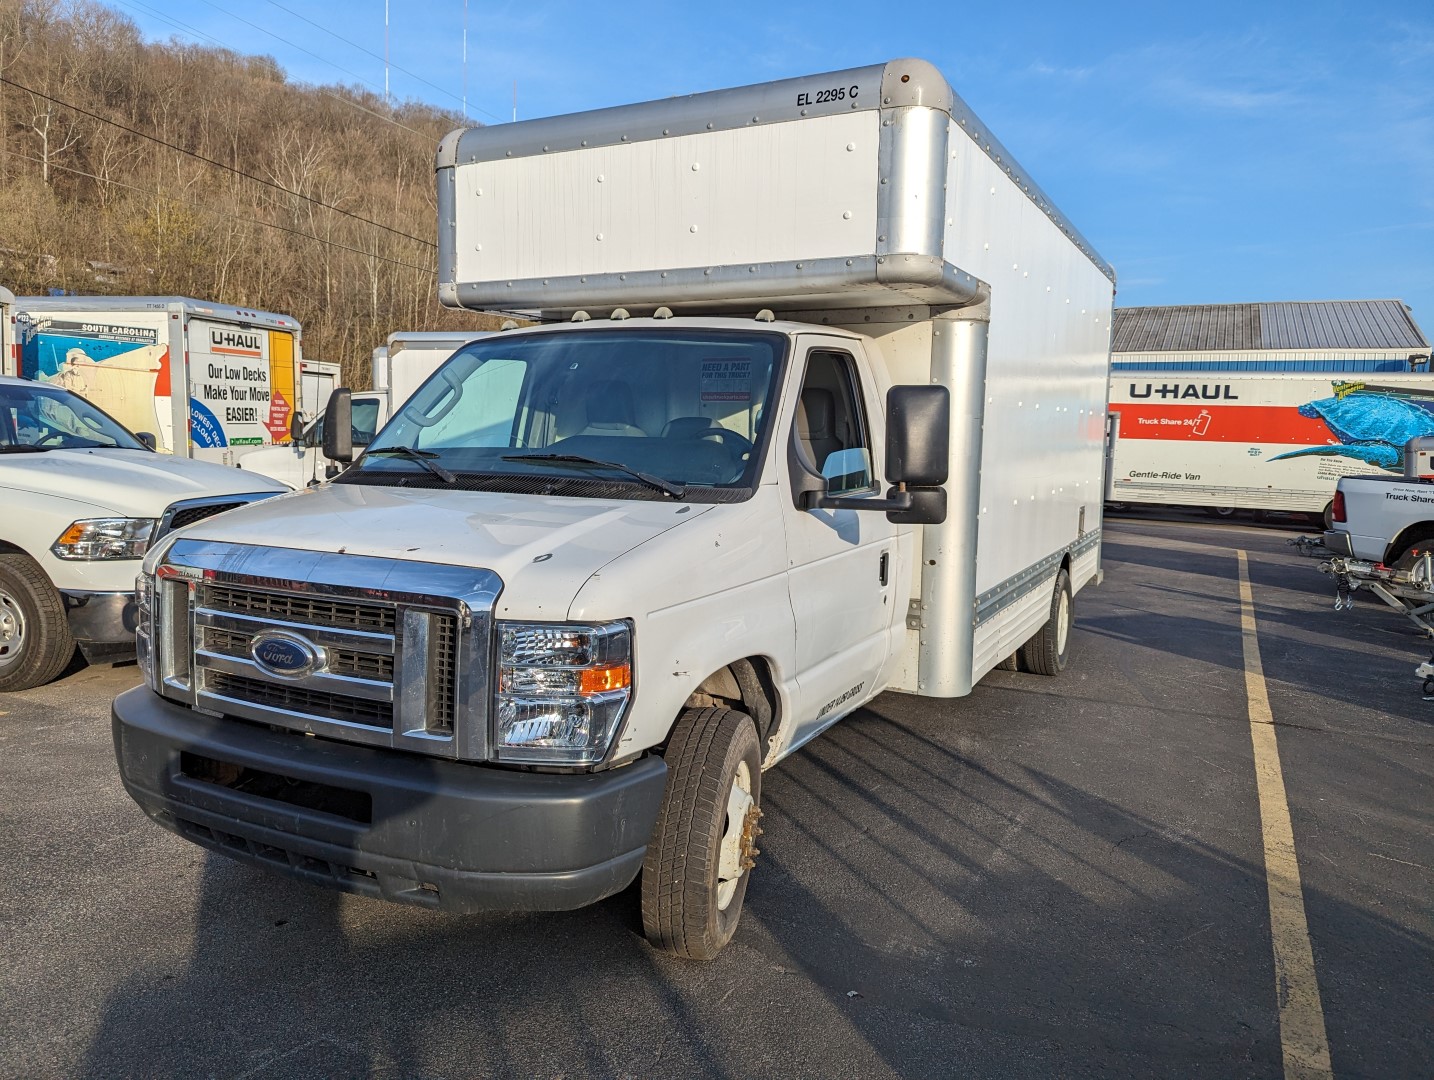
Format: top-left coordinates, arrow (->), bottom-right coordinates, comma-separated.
0,555 -> 75,693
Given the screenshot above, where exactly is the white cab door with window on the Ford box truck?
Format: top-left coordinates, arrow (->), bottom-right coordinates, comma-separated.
784,338 -> 896,742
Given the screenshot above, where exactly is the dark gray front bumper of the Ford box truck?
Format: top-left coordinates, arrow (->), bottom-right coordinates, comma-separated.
113,687 -> 667,912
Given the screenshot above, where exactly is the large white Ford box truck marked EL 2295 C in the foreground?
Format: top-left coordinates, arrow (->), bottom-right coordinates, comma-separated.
113,60 -> 1113,958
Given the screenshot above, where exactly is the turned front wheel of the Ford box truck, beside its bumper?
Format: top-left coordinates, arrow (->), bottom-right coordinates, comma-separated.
642,709 -> 761,960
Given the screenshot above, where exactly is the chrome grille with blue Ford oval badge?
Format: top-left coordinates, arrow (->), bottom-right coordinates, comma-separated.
152,539 -> 502,760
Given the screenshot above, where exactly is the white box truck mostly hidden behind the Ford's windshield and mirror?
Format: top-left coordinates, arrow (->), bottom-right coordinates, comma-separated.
239,330 -> 492,488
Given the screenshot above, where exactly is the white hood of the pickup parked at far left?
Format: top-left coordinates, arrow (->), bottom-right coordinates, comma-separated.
0,447 -> 288,518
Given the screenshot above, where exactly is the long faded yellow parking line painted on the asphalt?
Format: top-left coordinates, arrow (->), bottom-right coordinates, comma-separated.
1235,551 -> 1334,1080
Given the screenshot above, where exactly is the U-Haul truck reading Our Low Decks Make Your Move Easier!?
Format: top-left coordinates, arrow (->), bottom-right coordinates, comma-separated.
14,297 -> 301,465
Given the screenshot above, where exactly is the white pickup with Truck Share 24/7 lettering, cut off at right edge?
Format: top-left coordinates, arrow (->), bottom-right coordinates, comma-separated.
1324,437 -> 1434,567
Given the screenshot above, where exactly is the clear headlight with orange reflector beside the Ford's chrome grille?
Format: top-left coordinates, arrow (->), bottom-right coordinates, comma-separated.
493,622 -> 632,764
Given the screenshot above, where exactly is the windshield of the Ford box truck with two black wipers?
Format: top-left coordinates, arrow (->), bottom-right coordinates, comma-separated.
343,328 -> 786,501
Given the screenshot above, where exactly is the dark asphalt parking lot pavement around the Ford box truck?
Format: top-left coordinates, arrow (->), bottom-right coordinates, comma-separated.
0,519 -> 1434,1077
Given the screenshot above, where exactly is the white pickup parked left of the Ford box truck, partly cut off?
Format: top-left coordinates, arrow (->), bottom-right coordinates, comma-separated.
0,376 -> 287,693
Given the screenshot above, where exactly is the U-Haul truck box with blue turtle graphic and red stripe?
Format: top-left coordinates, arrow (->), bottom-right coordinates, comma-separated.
1106,370 -> 1434,513
